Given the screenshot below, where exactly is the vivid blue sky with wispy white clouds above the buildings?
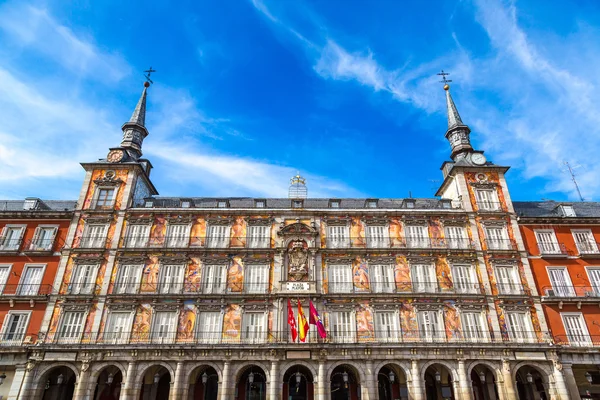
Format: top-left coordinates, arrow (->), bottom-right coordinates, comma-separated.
0,0 -> 600,200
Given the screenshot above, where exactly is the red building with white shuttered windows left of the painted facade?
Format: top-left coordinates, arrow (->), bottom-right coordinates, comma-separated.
0,198 -> 75,399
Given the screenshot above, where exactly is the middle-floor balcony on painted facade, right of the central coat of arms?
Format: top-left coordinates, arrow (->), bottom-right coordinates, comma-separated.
327,281 -> 485,295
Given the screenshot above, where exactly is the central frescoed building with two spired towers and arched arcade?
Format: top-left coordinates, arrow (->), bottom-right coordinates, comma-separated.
0,84 -> 571,400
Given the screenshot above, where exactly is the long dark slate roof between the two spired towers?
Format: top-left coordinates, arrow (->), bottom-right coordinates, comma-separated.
136,197 -> 449,209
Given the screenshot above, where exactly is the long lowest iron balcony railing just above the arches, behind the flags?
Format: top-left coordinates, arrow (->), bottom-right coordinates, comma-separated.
43,328 -> 551,346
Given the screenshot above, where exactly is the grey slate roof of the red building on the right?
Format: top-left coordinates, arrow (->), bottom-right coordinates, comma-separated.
513,201 -> 600,219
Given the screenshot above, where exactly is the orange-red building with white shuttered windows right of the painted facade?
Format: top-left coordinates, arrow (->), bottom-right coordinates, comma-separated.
515,201 -> 600,400
